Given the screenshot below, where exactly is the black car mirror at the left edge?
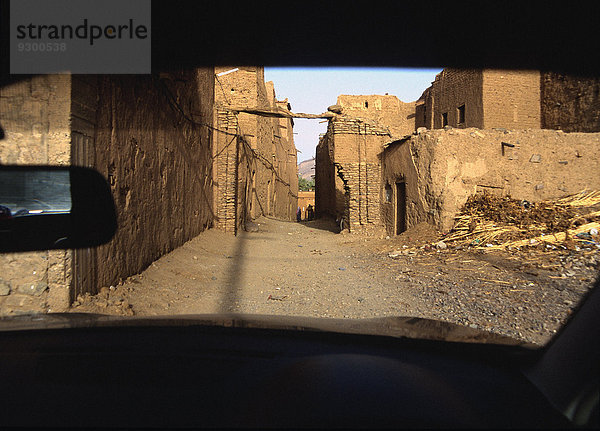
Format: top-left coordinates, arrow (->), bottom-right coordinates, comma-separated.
0,165 -> 117,252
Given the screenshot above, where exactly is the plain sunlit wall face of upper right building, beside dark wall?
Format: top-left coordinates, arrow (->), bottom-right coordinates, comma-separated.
480,69 -> 541,129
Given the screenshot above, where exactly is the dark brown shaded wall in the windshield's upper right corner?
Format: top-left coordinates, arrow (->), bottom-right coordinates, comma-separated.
540,72 -> 600,132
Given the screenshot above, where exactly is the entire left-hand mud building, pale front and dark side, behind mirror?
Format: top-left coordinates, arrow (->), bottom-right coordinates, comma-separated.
0,68 -> 214,313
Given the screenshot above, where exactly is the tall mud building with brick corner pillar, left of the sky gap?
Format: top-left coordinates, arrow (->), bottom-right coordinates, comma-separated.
213,67 -> 298,233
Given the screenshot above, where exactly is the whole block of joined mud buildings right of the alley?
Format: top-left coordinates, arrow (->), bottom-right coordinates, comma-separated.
315,69 -> 600,235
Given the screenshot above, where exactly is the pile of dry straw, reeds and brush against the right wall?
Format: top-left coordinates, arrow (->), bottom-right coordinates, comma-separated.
444,191 -> 600,248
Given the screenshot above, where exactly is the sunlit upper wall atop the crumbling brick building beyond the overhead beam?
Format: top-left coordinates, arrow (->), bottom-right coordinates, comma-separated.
337,94 -> 416,137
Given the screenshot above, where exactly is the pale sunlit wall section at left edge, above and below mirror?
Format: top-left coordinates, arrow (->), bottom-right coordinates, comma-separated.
0,75 -> 72,315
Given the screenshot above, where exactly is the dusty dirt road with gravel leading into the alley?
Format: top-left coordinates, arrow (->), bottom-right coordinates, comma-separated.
71,218 -> 600,344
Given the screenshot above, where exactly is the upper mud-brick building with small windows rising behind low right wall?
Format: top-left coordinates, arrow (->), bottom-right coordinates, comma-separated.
414,68 -> 600,132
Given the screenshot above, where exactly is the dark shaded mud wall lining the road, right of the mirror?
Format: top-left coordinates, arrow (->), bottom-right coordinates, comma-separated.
94,68 -> 214,287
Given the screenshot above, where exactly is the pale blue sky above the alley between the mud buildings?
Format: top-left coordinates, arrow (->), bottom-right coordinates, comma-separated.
265,67 -> 442,163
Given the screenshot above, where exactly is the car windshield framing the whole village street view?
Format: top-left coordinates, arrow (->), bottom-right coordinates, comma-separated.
0,65 -> 600,345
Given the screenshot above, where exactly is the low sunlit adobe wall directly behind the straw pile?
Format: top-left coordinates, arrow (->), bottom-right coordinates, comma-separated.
381,128 -> 600,234
